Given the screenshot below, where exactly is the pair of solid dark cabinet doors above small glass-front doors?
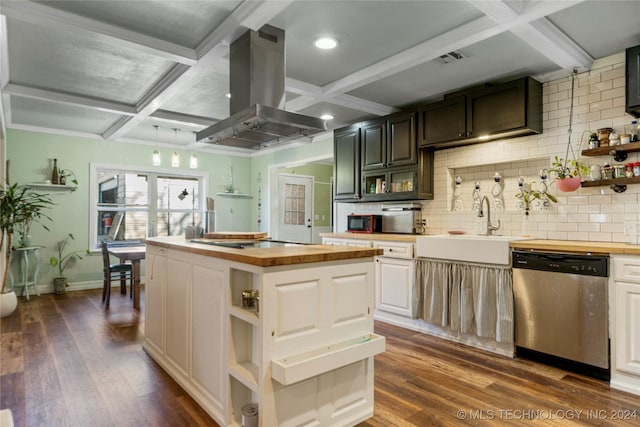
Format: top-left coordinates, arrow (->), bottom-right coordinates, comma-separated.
360,111 -> 417,171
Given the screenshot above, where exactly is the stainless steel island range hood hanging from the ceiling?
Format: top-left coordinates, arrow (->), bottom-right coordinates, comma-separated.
196,25 -> 327,150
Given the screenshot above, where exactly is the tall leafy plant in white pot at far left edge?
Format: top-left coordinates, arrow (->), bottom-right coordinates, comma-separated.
0,183 -> 53,317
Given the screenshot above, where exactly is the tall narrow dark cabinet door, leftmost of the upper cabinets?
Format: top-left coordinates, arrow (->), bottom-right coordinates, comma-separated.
333,126 -> 360,201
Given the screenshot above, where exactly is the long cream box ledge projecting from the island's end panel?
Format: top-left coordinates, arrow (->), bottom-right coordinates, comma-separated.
271,334 -> 385,385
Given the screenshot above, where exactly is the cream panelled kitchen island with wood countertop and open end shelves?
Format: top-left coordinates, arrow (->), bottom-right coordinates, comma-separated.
143,237 -> 384,427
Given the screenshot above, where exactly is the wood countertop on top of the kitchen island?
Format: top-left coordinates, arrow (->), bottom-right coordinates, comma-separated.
145,236 -> 383,267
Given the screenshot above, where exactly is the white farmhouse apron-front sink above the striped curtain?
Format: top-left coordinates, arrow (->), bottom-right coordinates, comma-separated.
416,234 -> 527,265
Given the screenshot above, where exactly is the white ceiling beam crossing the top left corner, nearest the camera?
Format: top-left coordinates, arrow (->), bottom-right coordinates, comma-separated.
2,1 -> 197,65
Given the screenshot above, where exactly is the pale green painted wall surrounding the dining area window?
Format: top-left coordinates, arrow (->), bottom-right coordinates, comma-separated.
6,129 -> 256,283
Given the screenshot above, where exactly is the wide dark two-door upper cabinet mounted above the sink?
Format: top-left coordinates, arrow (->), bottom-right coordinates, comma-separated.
418,77 -> 542,149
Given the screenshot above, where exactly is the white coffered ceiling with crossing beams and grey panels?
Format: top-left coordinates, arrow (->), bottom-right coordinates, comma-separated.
0,0 -> 640,154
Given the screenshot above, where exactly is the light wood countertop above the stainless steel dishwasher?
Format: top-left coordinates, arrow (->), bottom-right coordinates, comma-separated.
509,240 -> 640,255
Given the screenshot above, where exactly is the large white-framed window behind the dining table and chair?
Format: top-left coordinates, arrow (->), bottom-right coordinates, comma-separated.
90,164 -> 208,249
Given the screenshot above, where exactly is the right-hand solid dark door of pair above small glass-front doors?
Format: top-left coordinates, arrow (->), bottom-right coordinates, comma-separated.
386,112 -> 417,167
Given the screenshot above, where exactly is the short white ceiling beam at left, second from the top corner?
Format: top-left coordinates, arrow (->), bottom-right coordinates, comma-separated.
3,83 -> 137,116
